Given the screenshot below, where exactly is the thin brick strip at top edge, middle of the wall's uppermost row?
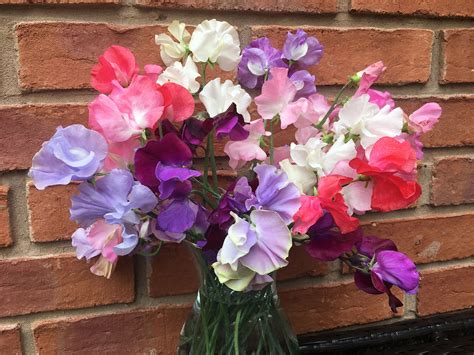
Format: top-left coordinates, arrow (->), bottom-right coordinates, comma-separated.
137,0 -> 337,14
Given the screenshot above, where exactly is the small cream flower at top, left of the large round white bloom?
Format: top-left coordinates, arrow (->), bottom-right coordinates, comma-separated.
155,20 -> 191,65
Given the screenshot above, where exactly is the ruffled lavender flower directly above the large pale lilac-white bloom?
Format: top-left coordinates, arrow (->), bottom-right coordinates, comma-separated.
245,164 -> 301,224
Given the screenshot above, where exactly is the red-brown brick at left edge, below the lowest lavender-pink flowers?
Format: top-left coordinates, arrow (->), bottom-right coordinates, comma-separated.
0,255 -> 135,317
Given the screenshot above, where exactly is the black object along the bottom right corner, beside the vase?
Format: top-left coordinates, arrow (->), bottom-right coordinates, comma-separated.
299,311 -> 474,355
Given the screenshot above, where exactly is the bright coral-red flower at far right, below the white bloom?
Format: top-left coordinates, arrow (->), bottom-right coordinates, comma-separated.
349,137 -> 421,212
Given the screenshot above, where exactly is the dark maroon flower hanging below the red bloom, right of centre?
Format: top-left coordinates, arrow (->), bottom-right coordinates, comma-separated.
306,228 -> 362,261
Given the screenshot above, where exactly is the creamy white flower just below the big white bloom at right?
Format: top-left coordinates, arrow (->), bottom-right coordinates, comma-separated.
290,136 -> 357,176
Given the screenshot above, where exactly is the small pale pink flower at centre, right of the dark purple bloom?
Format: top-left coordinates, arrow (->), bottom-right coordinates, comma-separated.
224,119 -> 267,170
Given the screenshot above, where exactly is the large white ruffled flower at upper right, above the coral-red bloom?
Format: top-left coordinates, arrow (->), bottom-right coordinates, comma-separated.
334,94 -> 404,148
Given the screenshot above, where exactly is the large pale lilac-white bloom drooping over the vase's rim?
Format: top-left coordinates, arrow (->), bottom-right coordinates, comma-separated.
212,210 -> 292,291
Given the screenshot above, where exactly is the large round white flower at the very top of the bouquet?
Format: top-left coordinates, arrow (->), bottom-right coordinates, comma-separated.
189,19 -> 240,71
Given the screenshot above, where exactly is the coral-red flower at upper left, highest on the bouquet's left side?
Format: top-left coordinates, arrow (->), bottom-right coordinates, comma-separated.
91,46 -> 138,94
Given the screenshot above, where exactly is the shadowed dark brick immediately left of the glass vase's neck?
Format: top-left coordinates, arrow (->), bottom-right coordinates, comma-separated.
148,244 -> 199,297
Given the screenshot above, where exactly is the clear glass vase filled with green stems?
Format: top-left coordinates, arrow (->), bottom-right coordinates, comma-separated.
178,247 -> 299,355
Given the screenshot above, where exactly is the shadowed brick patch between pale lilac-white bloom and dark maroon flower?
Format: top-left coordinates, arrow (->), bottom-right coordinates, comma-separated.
277,246 -> 328,280
